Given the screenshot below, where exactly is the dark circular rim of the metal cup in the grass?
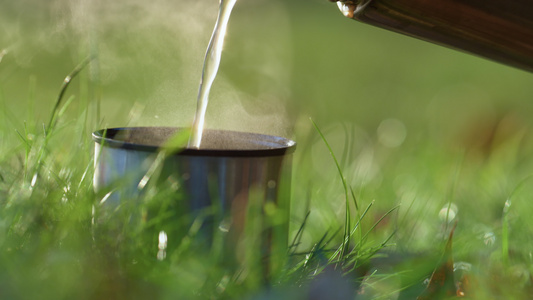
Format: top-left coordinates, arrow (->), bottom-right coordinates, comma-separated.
92,127 -> 296,157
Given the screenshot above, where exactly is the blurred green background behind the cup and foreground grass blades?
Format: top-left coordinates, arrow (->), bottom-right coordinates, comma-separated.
0,0 -> 533,294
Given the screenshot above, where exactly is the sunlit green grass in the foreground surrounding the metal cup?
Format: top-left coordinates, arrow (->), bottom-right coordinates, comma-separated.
0,60 -> 532,299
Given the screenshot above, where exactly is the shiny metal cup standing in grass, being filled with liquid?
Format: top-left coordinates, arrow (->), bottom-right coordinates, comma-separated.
93,127 -> 296,274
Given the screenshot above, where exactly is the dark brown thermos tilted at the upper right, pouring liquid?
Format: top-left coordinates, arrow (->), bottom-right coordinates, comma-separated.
329,0 -> 533,72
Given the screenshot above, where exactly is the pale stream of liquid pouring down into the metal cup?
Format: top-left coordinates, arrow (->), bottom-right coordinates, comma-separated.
187,0 -> 237,149
